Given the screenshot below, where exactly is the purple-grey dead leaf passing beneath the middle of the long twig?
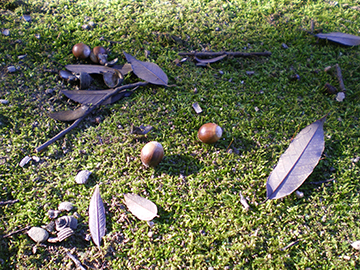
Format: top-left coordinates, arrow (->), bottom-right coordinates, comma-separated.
61,89 -> 132,105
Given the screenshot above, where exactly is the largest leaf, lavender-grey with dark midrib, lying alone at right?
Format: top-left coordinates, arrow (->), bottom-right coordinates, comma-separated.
266,116 -> 326,199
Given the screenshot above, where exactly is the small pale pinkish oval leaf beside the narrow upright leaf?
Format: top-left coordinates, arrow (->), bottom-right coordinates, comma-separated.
124,193 -> 157,220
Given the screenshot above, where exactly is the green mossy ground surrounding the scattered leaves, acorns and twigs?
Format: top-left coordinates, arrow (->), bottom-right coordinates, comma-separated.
0,0 -> 360,269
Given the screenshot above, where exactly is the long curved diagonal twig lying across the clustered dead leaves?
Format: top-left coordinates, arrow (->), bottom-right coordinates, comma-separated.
35,82 -> 148,152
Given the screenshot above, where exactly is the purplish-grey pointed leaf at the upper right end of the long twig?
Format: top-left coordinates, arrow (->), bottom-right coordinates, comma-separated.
124,52 -> 168,86
